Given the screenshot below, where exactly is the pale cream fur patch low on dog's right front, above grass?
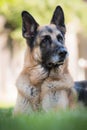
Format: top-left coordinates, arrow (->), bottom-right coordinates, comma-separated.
42,90 -> 69,111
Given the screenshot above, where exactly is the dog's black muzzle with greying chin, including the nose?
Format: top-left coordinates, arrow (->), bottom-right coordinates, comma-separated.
47,47 -> 68,68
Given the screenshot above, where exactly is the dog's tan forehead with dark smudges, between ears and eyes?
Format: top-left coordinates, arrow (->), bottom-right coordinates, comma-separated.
38,24 -> 61,36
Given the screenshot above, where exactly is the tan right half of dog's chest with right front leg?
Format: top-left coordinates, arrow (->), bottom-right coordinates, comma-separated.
41,61 -> 76,111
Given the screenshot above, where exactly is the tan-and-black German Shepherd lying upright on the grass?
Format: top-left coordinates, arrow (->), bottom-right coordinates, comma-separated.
14,6 -> 77,114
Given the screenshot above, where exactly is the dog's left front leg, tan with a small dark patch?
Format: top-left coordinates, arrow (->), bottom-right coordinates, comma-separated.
14,75 -> 40,115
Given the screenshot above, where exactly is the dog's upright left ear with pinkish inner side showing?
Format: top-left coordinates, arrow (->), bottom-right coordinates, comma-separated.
22,11 -> 39,39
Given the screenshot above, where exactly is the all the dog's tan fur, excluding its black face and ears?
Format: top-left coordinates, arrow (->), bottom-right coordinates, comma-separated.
14,24 -> 76,115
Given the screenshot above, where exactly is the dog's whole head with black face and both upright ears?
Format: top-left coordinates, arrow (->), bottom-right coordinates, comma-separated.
22,6 -> 68,68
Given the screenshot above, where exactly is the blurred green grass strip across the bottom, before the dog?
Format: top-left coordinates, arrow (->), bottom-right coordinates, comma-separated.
0,108 -> 87,130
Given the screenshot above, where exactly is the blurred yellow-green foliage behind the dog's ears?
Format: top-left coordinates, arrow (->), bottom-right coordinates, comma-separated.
0,0 -> 87,42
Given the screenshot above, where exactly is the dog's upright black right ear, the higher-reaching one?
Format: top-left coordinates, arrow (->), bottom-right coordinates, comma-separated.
51,6 -> 66,33
